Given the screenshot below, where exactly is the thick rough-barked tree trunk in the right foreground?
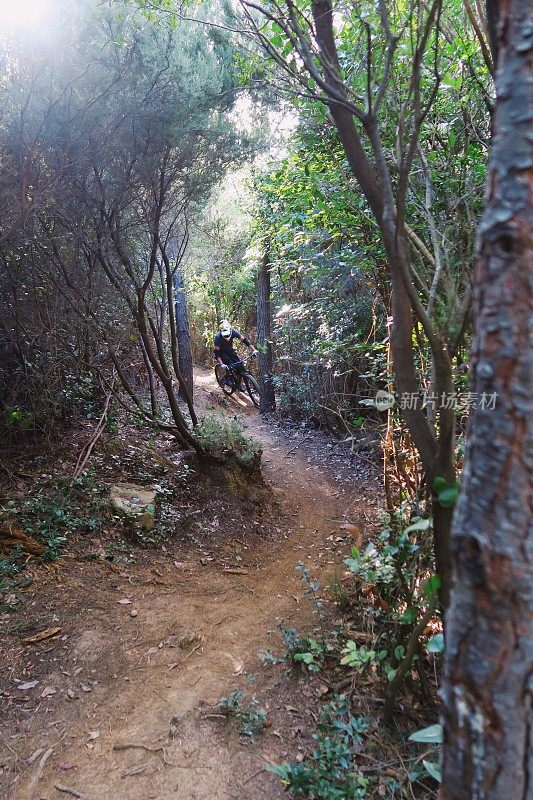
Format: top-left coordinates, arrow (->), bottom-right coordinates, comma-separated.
441,0 -> 533,800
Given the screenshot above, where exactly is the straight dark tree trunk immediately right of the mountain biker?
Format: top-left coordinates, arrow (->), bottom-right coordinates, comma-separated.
257,248 -> 276,414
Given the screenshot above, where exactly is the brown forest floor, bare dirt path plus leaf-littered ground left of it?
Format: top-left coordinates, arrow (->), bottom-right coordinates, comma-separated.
0,370 -> 380,800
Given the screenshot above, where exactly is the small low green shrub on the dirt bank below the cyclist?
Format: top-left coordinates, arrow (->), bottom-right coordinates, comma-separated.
195,416 -> 263,469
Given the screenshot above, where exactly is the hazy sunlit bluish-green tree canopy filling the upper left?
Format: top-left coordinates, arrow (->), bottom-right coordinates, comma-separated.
2,4 -> 250,444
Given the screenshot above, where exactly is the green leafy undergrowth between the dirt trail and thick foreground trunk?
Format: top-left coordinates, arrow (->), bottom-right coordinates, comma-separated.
261,515 -> 444,800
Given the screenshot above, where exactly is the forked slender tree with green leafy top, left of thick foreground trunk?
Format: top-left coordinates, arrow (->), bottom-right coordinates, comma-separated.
241,0 -> 490,607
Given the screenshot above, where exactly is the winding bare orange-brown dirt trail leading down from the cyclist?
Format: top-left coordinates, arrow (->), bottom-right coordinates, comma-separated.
0,371 -> 375,800
